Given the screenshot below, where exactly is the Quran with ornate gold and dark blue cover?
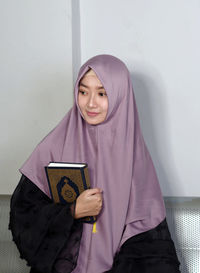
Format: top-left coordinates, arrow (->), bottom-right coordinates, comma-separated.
45,162 -> 96,223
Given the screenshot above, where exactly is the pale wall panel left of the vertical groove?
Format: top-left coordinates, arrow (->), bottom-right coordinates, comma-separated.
0,0 -> 73,194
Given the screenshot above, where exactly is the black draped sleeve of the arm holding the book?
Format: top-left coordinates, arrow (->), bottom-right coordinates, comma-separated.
9,175 -> 83,273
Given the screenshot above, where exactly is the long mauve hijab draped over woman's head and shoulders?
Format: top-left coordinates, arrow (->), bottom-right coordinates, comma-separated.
20,55 -> 165,273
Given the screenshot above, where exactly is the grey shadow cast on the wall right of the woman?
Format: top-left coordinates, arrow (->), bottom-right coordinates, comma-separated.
131,73 -> 180,196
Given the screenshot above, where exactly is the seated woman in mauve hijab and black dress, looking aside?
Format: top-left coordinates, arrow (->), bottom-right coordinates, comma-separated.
9,55 -> 180,273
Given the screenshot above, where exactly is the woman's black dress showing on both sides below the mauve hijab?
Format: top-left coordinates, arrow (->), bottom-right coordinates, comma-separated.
9,175 -> 180,273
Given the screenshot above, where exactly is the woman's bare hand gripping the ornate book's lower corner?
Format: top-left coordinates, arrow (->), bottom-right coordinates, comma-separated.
74,188 -> 102,219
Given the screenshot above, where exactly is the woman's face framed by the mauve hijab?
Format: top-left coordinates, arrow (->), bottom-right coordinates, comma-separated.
78,69 -> 108,125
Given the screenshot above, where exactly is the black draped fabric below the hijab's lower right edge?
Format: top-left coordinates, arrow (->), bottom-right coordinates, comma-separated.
105,219 -> 180,273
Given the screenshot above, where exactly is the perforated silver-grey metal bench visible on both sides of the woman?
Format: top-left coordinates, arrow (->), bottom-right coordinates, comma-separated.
0,195 -> 200,273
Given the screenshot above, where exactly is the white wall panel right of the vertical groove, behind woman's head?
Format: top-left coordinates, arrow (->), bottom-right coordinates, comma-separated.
80,0 -> 200,196
